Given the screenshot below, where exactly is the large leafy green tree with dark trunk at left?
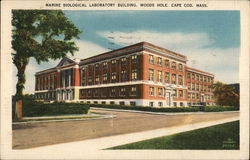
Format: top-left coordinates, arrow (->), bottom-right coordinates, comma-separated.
12,10 -> 81,98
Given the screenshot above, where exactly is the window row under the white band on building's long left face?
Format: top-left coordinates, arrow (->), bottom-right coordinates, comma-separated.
80,86 -> 138,98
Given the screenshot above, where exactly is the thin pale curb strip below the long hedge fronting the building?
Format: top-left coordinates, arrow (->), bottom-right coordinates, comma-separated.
90,107 -> 240,115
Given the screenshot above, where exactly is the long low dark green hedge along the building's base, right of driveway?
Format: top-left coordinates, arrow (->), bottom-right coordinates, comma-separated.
90,104 -> 239,112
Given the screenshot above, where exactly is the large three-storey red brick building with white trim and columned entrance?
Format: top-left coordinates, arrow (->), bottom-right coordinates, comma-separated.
35,42 -> 214,107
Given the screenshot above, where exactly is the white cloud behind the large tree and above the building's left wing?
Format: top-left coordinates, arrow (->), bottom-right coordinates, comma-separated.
12,40 -> 108,94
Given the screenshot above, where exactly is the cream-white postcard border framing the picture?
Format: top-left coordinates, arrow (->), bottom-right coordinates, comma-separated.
0,0 -> 250,159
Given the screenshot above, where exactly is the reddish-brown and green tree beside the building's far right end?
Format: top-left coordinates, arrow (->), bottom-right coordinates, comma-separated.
213,81 -> 239,106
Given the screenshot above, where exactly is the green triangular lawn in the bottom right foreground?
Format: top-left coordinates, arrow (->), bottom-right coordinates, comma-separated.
109,121 -> 239,149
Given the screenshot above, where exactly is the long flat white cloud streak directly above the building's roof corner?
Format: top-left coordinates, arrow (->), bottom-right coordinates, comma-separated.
97,31 -> 214,49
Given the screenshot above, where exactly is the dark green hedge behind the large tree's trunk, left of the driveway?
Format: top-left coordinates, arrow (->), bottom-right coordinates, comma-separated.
12,96 -> 90,118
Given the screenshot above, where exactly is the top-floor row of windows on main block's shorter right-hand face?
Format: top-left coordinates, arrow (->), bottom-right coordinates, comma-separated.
149,55 -> 183,72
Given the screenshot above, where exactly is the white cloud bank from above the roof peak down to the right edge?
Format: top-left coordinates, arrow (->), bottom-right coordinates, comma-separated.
97,31 -> 240,83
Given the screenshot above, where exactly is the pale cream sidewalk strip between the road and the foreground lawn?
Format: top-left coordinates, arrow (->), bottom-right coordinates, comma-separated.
23,117 -> 239,153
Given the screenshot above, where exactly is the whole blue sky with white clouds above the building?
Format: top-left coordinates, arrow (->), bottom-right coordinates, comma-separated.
13,10 -> 240,94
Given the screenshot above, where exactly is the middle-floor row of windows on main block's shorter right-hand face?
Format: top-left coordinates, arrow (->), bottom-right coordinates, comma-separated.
149,69 -> 184,85
